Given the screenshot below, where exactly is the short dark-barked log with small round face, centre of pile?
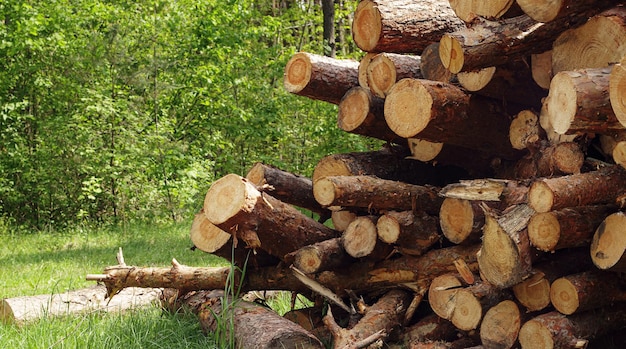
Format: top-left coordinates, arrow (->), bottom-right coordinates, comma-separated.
376,211 -> 441,256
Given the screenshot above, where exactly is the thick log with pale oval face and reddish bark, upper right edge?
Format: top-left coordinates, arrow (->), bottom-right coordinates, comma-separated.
541,67 -> 624,134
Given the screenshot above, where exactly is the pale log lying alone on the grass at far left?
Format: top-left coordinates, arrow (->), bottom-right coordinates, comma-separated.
0,285 -> 161,326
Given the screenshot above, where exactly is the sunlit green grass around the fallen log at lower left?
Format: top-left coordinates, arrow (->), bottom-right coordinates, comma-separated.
0,221 -> 232,349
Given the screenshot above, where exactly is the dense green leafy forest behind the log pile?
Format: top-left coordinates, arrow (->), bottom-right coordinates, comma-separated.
0,0 -> 378,231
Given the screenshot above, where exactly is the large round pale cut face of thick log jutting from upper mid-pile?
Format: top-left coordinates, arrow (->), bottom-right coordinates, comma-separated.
385,78 -> 433,138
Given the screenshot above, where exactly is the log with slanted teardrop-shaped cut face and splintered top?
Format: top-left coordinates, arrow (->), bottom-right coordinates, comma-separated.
477,204 -> 538,287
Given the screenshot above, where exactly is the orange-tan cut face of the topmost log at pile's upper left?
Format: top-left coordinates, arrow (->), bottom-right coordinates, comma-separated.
352,0 -> 382,52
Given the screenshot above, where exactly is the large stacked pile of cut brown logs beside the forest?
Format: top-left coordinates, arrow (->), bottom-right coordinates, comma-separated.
89,0 -> 626,348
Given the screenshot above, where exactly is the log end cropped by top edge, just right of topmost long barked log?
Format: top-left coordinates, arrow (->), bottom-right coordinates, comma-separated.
449,0 -> 519,23
